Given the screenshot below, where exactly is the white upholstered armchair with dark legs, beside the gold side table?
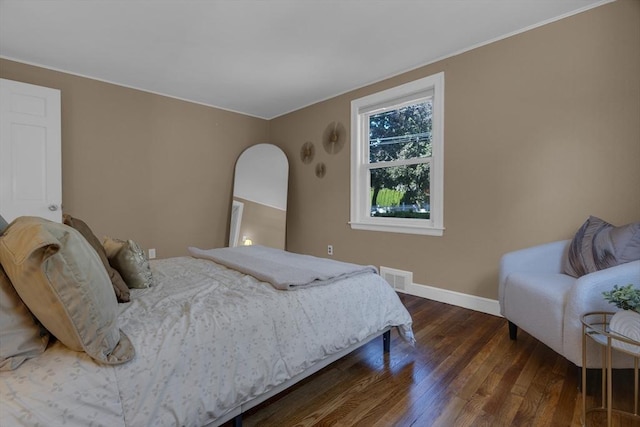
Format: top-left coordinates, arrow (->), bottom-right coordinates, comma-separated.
498,240 -> 640,368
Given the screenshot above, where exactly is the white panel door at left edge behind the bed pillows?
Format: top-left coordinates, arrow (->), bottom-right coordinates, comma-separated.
0,79 -> 62,222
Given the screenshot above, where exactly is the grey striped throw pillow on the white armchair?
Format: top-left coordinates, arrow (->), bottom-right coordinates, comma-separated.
564,216 -> 640,277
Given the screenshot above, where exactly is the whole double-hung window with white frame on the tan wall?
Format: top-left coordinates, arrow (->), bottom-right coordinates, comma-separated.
351,73 -> 444,236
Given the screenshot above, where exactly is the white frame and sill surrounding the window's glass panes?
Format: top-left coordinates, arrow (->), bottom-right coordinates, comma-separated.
349,72 -> 444,236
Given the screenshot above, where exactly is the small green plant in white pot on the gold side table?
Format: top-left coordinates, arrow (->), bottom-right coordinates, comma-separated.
602,284 -> 640,355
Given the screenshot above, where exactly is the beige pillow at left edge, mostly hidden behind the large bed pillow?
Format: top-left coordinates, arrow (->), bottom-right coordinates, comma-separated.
0,266 -> 49,371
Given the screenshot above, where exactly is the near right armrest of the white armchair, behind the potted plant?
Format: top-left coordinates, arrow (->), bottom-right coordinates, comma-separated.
563,260 -> 640,366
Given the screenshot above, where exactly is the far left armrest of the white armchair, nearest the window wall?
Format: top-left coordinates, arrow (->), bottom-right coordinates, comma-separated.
498,240 -> 571,314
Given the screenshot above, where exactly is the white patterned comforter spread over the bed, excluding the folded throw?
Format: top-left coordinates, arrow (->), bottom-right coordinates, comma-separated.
0,257 -> 413,427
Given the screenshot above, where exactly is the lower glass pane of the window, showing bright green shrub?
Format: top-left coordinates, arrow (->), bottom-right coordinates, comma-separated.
370,163 -> 431,219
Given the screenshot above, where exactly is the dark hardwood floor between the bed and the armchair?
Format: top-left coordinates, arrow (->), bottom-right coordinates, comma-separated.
235,294 -> 640,427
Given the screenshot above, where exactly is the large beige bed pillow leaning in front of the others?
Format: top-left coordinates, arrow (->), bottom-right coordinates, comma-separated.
0,217 -> 135,364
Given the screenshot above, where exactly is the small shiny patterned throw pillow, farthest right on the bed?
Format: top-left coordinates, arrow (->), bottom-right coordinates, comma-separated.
102,237 -> 153,289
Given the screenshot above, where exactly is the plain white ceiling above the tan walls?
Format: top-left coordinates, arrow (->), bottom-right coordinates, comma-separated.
0,0 -> 610,119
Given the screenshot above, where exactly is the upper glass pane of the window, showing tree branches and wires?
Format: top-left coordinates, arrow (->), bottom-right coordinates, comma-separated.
369,98 -> 433,163
